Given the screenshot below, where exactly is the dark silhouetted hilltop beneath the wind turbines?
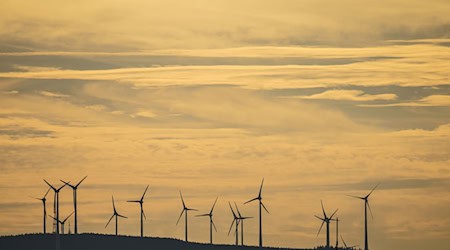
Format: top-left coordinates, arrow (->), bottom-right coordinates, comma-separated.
0,234 -> 322,250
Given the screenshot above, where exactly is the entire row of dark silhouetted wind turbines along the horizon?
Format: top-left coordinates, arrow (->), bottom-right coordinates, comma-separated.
35,176 -> 378,250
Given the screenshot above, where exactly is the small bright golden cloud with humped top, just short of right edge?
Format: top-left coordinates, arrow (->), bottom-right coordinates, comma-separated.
290,90 -> 397,102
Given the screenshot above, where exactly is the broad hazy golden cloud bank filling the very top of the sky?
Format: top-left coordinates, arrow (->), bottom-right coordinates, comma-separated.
0,0 -> 449,51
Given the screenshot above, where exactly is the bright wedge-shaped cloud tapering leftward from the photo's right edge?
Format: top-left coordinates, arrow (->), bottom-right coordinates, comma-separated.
359,95 -> 450,107
